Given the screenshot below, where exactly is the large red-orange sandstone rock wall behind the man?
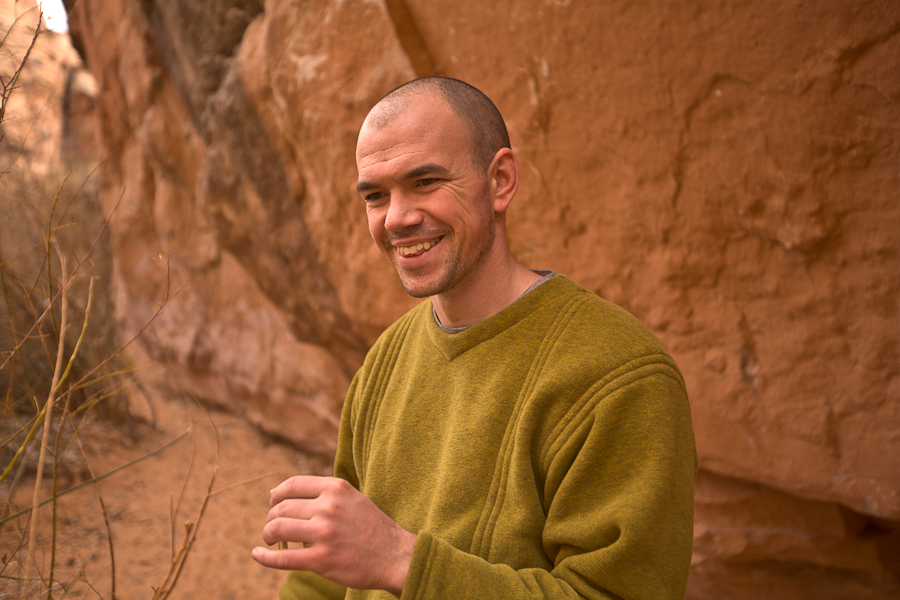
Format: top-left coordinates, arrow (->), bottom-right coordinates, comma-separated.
61,0 -> 900,599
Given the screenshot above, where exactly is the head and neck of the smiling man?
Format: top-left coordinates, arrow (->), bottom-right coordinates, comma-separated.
356,79 -> 539,326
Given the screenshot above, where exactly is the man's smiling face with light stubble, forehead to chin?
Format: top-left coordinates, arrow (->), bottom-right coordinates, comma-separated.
356,95 -> 496,298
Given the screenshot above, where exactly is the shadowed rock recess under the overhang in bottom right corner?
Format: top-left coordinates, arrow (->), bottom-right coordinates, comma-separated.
688,471 -> 900,599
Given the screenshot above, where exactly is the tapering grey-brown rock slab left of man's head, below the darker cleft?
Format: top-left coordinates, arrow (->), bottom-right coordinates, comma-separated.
198,71 -> 366,375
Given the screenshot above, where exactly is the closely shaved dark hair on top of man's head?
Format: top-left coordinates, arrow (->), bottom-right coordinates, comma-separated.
366,77 -> 510,171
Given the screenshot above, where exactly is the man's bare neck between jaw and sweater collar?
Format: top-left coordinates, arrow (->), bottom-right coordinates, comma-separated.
431,254 -> 540,327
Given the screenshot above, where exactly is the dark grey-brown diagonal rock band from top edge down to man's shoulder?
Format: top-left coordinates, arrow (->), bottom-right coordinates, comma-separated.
131,0 -> 366,376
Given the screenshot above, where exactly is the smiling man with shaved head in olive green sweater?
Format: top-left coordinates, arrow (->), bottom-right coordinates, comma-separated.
253,78 -> 696,600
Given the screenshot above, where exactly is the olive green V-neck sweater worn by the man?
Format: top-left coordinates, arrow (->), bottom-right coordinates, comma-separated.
282,276 -> 696,600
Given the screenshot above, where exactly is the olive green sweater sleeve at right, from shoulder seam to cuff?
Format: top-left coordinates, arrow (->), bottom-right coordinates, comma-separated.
402,365 -> 697,600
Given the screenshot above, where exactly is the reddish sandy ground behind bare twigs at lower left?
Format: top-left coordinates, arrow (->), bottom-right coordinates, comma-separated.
0,392 -> 330,600
